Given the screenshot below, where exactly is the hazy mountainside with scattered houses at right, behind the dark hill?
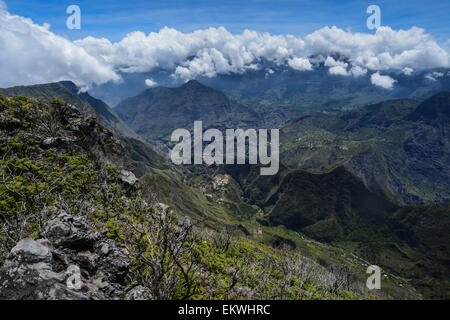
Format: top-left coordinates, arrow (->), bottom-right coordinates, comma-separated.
281,92 -> 450,204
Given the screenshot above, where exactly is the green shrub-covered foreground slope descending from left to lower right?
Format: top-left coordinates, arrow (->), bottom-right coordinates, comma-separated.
0,96 -> 384,299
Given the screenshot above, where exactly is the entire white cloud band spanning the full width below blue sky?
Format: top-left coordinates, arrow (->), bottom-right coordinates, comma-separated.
0,0 -> 450,86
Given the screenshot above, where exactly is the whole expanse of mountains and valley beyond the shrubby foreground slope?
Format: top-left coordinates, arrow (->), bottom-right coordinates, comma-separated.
0,75 -> 450,298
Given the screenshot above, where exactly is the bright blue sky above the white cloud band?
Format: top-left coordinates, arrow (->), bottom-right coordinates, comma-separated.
5,0 -> 450,43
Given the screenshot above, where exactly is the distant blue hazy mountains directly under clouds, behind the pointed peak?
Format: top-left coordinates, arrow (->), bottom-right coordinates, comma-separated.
90,61 -> 450,114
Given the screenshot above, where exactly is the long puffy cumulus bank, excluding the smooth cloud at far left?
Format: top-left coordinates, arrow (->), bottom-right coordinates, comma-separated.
75,27 -> 450,79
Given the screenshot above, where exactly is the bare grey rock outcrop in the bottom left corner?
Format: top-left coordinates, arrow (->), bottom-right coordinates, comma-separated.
0,210 -> 133,300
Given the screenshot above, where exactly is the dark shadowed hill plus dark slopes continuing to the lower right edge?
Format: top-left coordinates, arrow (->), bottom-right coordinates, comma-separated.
209,166 -> 450,298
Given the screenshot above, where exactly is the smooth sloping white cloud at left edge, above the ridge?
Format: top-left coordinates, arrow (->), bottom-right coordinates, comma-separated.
0,5 -> 120,87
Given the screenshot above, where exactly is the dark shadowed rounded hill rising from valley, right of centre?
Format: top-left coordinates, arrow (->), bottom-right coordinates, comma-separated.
218,166 -> 397,242
